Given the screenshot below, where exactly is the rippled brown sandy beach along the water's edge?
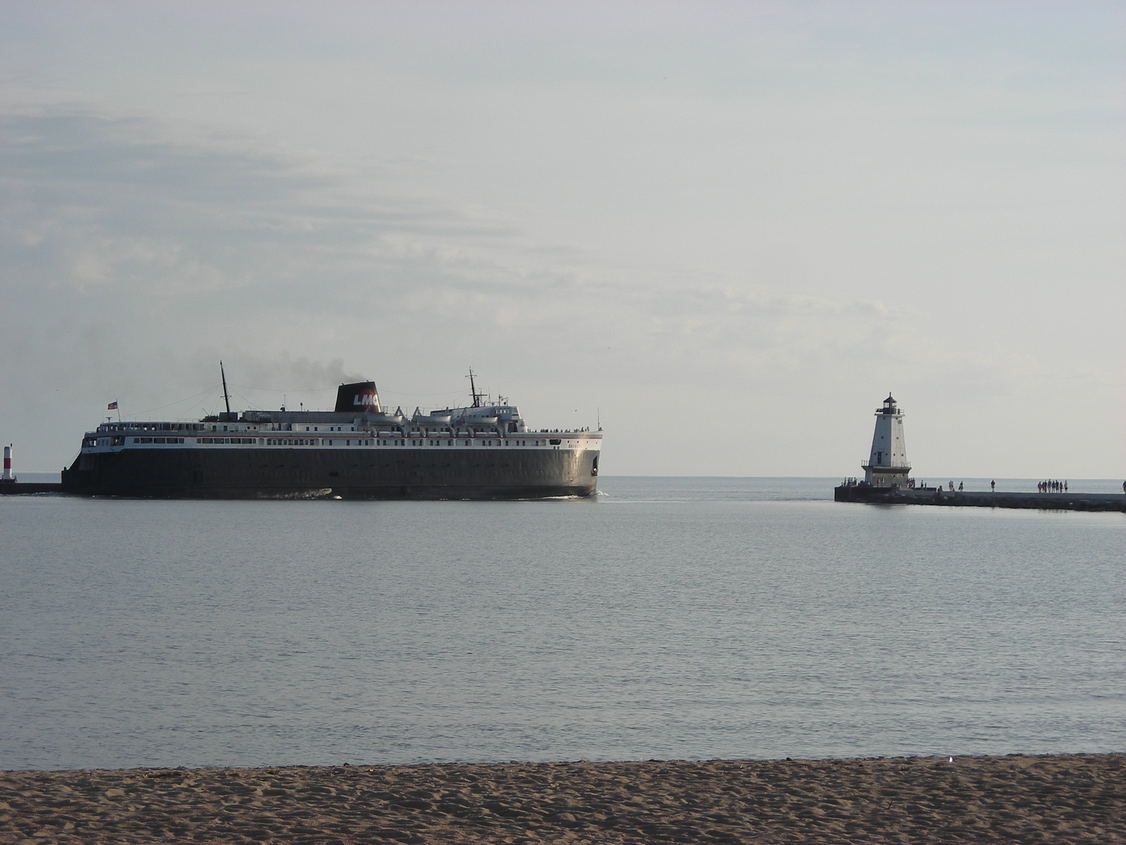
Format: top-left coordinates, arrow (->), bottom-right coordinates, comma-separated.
0,754 -> 1126,843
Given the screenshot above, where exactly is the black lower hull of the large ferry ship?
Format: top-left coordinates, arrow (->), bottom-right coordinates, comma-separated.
62,446 -> 599,499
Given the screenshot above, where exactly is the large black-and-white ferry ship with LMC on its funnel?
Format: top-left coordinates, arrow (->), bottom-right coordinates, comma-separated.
61,371 -> 602,499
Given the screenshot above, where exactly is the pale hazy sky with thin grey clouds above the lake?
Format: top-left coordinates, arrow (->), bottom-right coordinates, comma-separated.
0,0 -> 1126,479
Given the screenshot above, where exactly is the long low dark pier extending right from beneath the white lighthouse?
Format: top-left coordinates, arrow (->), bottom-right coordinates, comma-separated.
833,483 -> 1126,513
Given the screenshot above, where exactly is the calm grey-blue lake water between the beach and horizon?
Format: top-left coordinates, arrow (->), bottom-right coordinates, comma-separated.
0,478 -> 1126,768
